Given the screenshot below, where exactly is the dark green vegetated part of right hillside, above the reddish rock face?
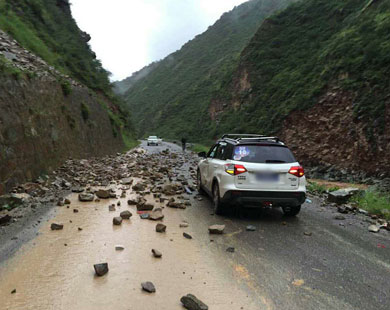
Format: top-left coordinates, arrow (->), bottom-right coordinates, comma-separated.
214,0 -> 390,140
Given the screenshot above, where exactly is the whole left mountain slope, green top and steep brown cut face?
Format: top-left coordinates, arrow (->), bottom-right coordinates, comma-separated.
0,0 -> 135,194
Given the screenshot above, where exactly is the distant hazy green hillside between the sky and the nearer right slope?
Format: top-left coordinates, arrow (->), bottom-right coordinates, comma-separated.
120,0 -> 292,143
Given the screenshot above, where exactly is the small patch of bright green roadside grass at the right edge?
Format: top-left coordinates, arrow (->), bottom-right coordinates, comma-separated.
351,190 -> 390,220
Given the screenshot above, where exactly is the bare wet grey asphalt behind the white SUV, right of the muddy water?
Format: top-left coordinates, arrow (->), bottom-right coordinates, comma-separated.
145,144 -> 390,310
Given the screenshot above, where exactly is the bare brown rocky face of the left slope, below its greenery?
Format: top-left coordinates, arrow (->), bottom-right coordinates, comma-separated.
0,1 -> 136,194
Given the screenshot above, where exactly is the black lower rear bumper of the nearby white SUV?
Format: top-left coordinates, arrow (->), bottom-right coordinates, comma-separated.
221,190 -> 306,207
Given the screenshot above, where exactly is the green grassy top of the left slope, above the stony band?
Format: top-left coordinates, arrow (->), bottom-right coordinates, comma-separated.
0,0 -> 111,94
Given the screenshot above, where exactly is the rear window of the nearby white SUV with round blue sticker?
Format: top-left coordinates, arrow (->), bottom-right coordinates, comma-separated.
233,145 -> 296,164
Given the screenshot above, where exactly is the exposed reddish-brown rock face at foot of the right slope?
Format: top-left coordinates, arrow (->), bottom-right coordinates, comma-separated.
279,90 -> 390,177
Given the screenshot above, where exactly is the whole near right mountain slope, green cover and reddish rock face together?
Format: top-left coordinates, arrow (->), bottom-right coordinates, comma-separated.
216,0 -> 390,177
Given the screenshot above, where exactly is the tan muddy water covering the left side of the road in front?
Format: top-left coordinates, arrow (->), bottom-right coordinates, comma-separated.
0,188 -> 262,310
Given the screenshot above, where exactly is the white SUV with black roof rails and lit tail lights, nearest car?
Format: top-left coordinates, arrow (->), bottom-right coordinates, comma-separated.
197,134 -> 306,216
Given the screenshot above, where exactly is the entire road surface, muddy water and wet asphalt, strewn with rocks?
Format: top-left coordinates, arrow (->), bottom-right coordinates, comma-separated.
0,143 -> 390,310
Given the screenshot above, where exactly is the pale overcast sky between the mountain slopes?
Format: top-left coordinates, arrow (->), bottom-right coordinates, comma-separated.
71,0 -> 246,80
